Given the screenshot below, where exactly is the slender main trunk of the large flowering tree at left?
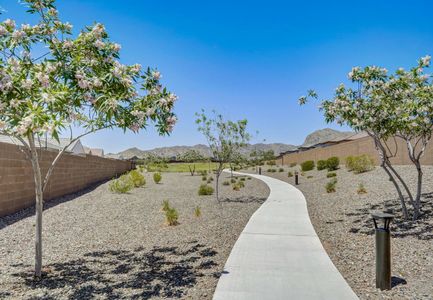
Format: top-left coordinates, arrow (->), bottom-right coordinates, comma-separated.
28,135 -> 43,278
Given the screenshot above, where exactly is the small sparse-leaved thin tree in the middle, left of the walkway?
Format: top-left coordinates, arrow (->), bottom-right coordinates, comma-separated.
196,110 -> 251,201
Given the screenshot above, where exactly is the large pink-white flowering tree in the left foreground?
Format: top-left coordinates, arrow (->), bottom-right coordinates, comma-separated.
0,0 -> 176,277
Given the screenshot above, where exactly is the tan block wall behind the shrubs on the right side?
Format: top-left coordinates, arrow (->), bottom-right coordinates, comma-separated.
277,137 -> 433,165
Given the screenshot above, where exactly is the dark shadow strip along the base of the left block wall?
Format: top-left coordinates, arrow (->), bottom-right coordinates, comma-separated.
0,179 -> 111,230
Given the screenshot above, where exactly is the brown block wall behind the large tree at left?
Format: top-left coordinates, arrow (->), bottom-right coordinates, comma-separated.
0,143 -> 133,217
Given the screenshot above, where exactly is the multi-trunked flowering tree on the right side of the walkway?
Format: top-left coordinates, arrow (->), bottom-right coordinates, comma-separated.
299,56 -> 433,219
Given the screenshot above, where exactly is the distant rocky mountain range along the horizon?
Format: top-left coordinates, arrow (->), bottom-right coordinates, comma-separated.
105,128 -> 353,159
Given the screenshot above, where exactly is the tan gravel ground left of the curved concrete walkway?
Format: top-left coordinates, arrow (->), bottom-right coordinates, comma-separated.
0,173 -> 269,299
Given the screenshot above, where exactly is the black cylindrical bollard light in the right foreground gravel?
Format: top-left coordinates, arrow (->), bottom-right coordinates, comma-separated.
371,212 -> 394,291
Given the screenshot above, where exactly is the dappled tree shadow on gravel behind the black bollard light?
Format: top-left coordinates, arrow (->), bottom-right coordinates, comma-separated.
346,193 -> 433,240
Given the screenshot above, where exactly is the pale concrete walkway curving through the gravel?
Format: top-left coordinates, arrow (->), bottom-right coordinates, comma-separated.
213,173 -> 358,300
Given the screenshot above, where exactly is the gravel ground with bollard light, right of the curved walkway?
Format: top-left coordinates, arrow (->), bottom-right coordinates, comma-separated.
243,166 -> 433,299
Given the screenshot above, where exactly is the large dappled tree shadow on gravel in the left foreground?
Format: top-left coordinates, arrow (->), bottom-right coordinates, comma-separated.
9,241 -> 218,299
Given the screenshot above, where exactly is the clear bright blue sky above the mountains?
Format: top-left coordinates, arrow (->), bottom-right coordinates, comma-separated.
0,0 -> 433,152
